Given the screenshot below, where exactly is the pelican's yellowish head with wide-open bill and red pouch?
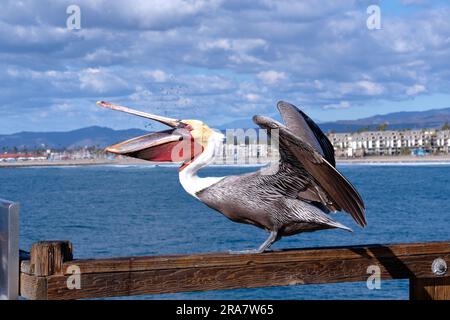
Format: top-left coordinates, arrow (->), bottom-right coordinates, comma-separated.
97,101 -> 214,169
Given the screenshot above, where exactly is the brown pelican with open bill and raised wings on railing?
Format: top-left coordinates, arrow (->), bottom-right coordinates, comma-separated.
98,101 -> 366,253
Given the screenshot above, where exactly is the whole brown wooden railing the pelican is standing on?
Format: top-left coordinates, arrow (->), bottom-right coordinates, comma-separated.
20,241 -> 450,299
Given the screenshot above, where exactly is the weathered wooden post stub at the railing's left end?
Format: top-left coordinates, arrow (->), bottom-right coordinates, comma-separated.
20,241 -> 73,300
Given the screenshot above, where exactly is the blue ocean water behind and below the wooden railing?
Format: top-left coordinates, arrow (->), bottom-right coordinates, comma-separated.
0,165 -> 450,299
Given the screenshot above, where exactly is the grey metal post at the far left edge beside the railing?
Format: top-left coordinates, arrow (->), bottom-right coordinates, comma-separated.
0,199 -> 19,300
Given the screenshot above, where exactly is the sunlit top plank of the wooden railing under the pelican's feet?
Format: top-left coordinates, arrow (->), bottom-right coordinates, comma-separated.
60,241 -> 450,275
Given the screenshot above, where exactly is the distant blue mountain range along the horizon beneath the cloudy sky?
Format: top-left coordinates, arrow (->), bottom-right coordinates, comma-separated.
0,108 -> 450,152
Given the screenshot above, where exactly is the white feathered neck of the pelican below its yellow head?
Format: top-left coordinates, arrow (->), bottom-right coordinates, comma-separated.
179,132 -> 224,198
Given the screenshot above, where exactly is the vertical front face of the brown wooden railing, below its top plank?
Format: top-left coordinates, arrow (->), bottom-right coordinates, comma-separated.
42,254 -> 450,299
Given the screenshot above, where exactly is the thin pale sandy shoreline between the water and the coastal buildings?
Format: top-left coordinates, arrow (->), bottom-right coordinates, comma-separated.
0,155 -> 450,169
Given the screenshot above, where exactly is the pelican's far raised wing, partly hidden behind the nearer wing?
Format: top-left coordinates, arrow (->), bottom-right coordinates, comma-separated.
277,101 -> 336,167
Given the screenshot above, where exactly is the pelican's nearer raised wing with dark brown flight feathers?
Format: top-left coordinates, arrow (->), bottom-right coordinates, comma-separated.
253,107 -> 366,226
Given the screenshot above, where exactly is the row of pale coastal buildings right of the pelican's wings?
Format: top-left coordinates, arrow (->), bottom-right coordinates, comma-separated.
328,129 -> 450,157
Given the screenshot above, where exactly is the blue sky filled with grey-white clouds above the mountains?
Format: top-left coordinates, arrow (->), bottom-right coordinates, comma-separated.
0,0 -> 450,133
